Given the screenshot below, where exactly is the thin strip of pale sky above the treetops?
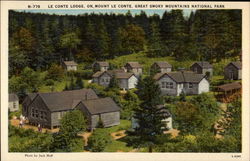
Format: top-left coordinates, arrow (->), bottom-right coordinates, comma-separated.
18,9 -> 194,17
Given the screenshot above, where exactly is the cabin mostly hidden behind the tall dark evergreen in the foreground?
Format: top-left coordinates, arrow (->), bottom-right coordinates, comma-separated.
131,105 -> 173,130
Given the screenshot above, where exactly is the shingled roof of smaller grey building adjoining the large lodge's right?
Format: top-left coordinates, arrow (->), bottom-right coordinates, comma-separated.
81,97 -> 120,115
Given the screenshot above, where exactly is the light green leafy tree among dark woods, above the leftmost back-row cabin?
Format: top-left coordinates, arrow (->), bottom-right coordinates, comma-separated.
60,32 -> 81,60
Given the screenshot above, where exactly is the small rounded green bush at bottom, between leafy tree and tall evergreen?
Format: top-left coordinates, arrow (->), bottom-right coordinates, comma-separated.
88,129 -> 112,152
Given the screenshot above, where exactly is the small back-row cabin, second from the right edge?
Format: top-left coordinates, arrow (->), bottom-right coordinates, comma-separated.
190,61 -> 213,77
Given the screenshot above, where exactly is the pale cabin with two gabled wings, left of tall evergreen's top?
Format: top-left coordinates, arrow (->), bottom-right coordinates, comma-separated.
92,69 -> 138,90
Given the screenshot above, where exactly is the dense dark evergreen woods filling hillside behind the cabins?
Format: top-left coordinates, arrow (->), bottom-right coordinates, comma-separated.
9,10 -> 241,76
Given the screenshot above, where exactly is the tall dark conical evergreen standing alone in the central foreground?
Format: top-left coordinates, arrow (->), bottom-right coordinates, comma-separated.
134,77 -> 166,152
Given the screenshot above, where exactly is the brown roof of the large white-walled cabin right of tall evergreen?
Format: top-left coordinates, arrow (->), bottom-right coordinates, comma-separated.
154,71 -> 205,83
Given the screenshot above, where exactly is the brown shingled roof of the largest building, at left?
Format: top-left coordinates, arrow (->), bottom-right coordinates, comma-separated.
38,89 -> 98,111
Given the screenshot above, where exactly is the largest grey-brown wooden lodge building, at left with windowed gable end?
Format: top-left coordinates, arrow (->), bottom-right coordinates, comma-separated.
23,89 -> 98,129
